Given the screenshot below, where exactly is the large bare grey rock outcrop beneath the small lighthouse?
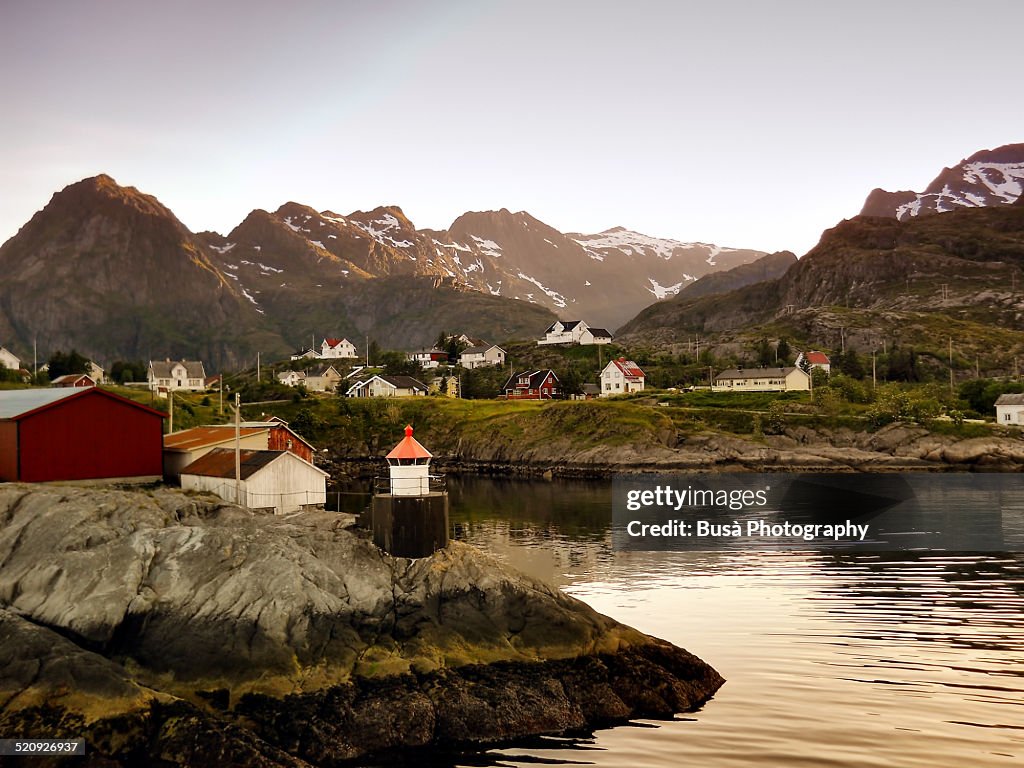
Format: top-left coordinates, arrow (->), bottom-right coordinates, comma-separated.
0,485 -> 722,765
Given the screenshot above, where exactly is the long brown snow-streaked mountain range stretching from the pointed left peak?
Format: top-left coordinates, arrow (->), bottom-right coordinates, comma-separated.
0,175 -> 763,370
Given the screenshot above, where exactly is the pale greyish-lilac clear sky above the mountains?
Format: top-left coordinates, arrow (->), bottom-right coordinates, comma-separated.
0,0 -> 1024,255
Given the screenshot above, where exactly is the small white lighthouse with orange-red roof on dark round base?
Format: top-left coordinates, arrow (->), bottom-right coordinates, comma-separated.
370,425 -> 449,557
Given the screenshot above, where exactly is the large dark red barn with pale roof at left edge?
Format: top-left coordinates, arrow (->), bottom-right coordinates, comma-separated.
0,387 -> 164,482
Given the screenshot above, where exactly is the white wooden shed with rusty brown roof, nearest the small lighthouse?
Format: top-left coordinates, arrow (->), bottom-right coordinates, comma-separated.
181,449 -> 329,515
